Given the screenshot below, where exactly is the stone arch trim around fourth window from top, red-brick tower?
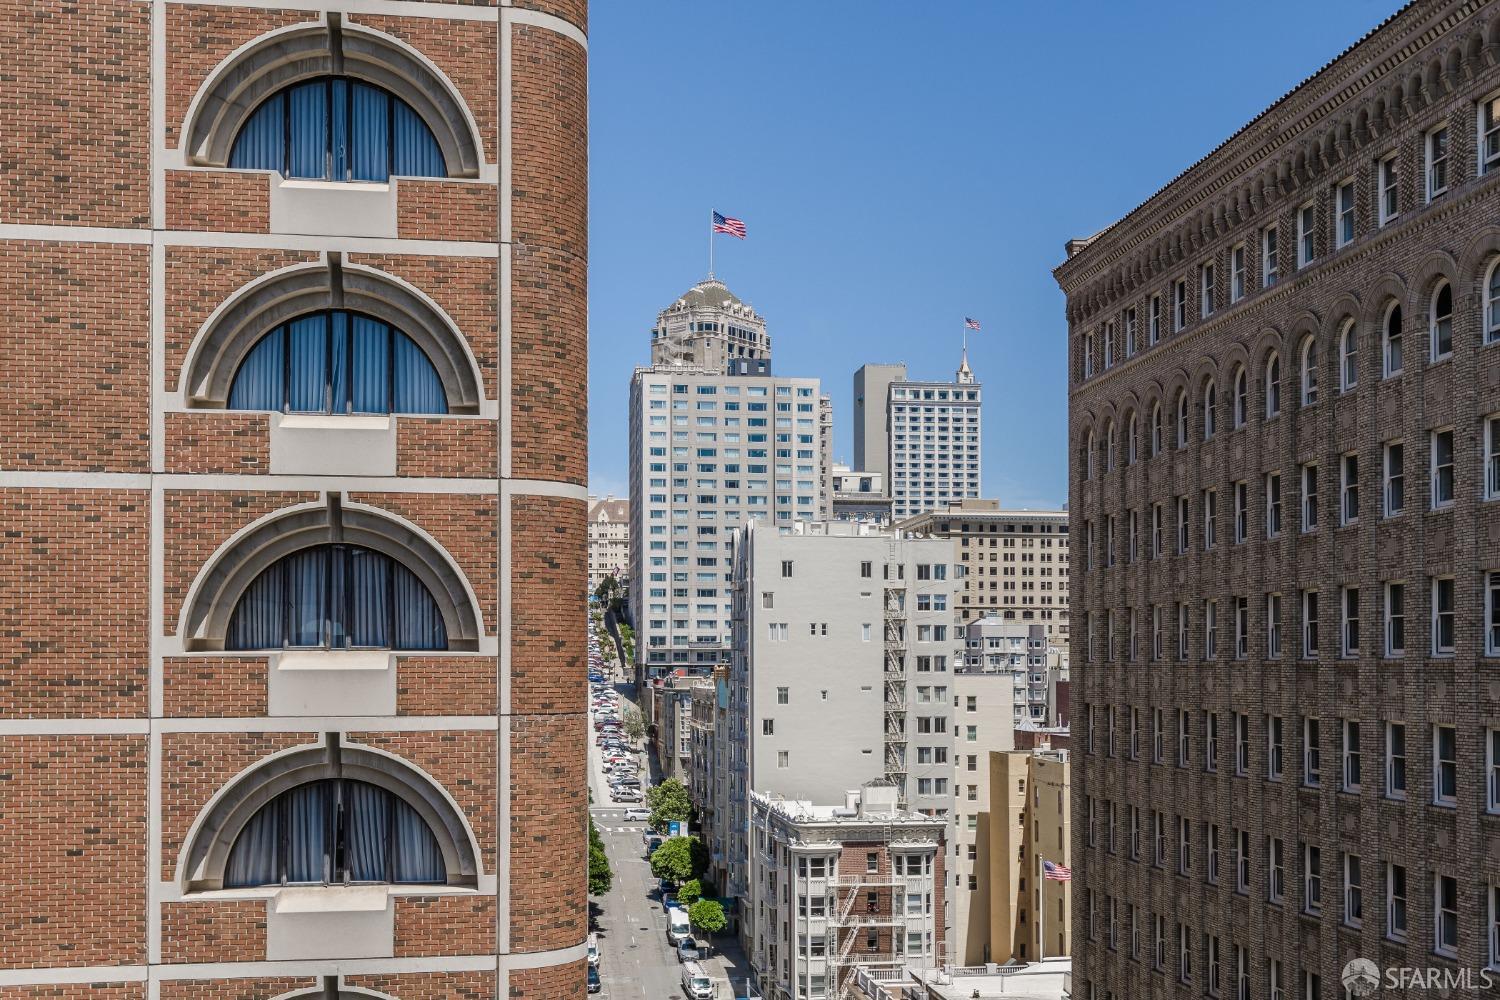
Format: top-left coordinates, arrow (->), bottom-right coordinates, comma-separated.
176,736 -> 485,893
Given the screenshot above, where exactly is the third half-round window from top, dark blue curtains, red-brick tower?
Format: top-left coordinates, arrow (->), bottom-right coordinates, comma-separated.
225,544 -> 449,649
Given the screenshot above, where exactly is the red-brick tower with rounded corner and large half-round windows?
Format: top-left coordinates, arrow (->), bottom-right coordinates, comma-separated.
0,0 -> 587,1000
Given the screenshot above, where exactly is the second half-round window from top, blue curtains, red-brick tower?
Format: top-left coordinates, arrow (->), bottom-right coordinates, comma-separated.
228,309 -> 449,414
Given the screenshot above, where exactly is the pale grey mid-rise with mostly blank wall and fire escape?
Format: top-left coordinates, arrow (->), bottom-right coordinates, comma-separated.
723,522 -> 953,895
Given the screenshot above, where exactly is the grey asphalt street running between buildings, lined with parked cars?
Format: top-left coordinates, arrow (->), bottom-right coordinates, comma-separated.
588,671 -> 744,1000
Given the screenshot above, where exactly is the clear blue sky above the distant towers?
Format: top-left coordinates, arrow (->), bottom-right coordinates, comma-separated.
590,0 -> 1400,507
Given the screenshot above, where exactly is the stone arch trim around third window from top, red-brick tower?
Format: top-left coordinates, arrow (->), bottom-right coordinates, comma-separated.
177,495 -> 485,651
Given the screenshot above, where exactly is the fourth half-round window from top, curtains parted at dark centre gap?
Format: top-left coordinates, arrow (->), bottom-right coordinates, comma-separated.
224,778 -> 447,889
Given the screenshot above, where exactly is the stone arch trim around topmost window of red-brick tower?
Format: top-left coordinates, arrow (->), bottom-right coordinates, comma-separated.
179,13 -> 485,177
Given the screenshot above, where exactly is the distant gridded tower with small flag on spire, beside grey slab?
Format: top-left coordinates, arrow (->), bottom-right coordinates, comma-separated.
854,355 -> 980,520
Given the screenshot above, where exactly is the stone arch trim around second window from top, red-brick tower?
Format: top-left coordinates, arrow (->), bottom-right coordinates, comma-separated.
177,262 -> 485,414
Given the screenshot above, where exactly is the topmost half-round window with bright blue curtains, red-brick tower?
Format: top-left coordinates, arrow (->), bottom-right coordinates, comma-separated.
230,76 -> 449,183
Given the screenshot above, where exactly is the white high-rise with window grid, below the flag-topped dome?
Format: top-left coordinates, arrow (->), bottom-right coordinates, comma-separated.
630,359 -> 825,676
